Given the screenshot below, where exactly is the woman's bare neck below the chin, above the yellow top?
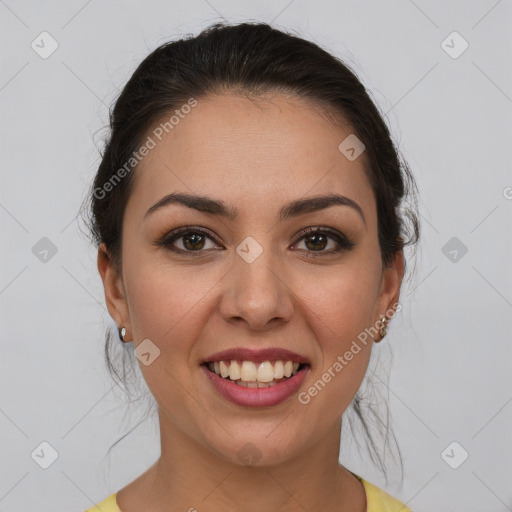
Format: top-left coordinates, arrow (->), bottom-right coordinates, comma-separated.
123,411 -> 366,512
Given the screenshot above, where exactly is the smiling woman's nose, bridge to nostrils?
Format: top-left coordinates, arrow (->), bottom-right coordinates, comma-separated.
220,250 -> 294,331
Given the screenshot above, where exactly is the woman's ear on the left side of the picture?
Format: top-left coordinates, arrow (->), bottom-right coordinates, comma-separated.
98,243 -> 131,341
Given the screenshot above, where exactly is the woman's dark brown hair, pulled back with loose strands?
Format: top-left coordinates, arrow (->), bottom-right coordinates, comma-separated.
83,23 -> 420,484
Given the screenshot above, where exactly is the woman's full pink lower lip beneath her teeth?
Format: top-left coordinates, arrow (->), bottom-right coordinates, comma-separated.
201,364 -> 309,407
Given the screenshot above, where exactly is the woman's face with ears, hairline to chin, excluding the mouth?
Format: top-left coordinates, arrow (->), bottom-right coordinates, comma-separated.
98,94 -> 403,464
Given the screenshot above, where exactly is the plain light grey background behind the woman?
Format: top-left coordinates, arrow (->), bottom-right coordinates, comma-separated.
0,0 -> 512,512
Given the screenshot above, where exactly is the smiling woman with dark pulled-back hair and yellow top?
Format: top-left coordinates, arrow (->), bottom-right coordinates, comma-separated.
84,23 -> 419,512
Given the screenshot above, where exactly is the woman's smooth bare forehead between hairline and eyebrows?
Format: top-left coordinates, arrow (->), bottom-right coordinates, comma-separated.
125,94 -> 373,218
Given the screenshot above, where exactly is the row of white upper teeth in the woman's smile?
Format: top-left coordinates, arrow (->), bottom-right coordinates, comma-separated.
208,359 -> 299,382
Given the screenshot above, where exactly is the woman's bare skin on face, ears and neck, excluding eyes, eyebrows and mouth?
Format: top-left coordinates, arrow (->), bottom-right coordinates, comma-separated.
98,94 -> 404,512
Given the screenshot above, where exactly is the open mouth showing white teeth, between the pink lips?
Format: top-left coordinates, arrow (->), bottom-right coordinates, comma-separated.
203,359 -> 309,388
